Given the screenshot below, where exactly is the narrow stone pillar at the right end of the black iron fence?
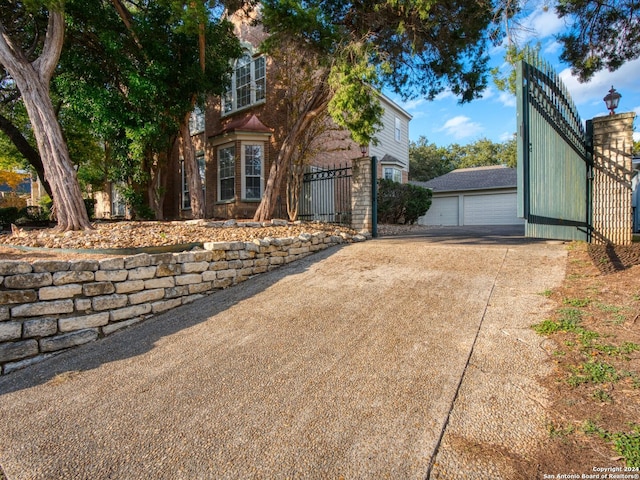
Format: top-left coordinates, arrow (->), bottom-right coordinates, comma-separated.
351,157 -> 373,234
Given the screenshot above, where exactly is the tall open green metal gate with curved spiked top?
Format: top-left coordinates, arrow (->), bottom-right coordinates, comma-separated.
516,51 -> 593,241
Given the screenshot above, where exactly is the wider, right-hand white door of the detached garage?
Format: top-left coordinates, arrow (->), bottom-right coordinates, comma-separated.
463,193 -> 524,225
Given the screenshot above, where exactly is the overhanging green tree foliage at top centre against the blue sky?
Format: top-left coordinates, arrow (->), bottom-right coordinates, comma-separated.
261,0 -> 500,148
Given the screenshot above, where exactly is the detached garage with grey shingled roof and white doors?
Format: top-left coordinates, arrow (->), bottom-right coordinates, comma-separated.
411,166 -> 524,226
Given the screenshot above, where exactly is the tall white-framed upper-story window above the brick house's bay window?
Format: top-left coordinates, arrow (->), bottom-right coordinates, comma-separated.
222,53 -> 267,114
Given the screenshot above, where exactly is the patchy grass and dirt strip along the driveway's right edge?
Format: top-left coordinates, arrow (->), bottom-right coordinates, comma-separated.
532,246 -> 640,468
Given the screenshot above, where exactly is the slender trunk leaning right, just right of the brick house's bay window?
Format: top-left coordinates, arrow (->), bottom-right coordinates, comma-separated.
253,78 -> 330,222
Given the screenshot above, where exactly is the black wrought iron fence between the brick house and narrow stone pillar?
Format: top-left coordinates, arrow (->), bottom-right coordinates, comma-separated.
298,165 -> 351,225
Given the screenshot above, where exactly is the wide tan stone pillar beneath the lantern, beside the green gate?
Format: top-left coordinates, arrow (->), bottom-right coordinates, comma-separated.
592,113 -> 635,245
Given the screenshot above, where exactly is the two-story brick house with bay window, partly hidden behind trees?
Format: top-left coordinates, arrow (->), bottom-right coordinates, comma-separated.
97,11 -> 411,219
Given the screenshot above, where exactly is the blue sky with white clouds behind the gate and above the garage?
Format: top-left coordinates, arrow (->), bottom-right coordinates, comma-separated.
389,5 -> 640,146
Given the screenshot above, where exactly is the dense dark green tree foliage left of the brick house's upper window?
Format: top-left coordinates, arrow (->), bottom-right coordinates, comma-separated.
54,0 -> 241,215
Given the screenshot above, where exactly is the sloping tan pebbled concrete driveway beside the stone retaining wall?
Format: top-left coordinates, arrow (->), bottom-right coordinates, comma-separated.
0,237 -> 566,480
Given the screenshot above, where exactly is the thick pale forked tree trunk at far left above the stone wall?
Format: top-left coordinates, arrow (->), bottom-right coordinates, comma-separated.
0,11 -> 92,230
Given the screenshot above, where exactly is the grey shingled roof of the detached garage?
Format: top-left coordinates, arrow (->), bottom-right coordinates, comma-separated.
411,165 -> 518,192
